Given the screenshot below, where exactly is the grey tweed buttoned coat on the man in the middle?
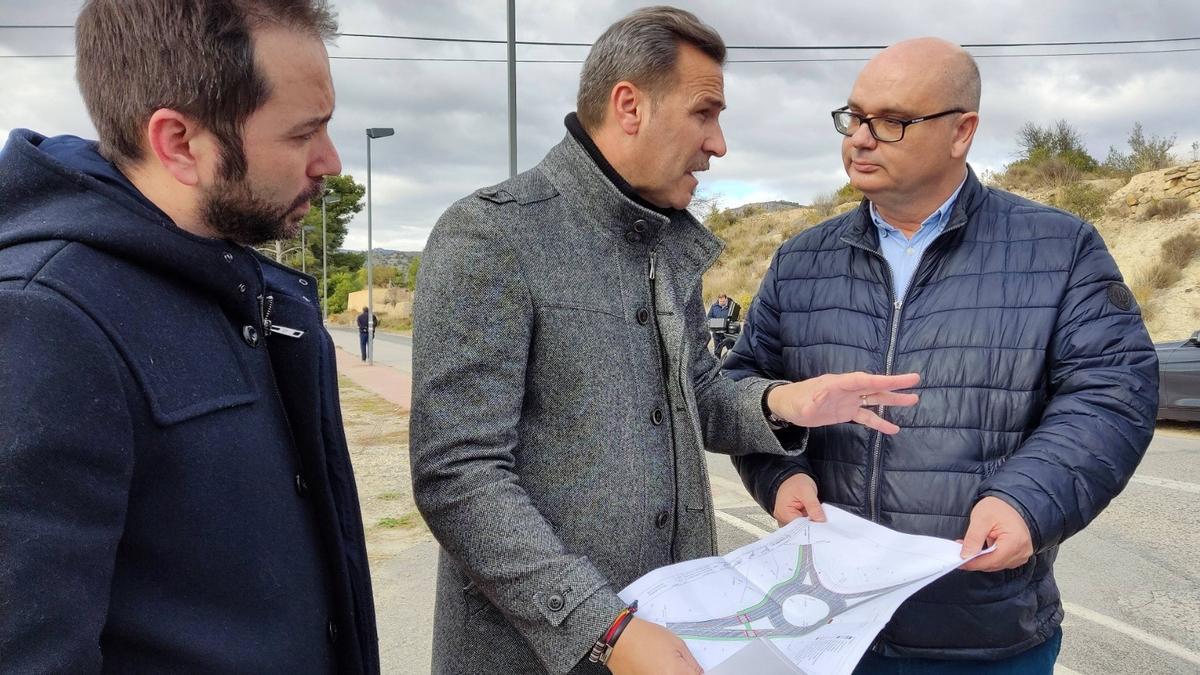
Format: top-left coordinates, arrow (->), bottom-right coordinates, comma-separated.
410,135 -> 784,674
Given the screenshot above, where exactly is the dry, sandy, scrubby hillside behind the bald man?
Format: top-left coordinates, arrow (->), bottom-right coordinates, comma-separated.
704,163 -> 1200,341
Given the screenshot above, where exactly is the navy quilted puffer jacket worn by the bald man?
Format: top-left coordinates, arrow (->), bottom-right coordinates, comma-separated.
726,168 -> 1158,659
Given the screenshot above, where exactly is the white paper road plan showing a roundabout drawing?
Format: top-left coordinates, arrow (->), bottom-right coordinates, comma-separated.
620,506 -> 988,675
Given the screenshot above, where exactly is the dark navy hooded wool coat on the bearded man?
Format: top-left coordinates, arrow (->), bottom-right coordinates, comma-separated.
0,130 -> 378,673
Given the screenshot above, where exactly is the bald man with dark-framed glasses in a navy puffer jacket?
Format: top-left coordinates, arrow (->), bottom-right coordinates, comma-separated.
725,38 -> 1158,674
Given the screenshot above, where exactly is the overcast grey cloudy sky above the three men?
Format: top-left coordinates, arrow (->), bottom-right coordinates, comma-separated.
0,0 -> 1200,250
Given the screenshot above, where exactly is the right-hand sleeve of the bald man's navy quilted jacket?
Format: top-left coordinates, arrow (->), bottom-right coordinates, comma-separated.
979,223 -> 1158,550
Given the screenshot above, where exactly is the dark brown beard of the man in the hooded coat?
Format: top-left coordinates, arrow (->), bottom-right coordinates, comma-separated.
200,172 -> 322,246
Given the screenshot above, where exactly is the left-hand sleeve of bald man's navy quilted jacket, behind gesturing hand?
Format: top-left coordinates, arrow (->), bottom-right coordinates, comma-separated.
724,247 -> 812,513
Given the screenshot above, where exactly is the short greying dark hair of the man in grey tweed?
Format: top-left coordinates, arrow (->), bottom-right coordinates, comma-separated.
575,6 -> 725,131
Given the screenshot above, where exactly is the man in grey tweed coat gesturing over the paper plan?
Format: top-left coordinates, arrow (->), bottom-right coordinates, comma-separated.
412,7 -> 918,675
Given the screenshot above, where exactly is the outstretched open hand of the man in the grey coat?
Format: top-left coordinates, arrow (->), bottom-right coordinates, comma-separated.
767,372 -> 920,434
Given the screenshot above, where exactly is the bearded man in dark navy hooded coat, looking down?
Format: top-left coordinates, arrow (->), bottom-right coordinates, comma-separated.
0,0 -> 378,673
